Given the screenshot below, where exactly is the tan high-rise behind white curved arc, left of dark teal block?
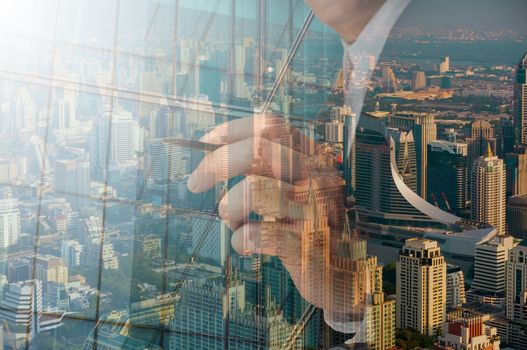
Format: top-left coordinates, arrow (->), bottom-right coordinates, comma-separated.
390,112 -> 437,198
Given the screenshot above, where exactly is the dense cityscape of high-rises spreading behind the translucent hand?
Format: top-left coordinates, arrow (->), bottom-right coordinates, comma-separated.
0,1 -> 527,350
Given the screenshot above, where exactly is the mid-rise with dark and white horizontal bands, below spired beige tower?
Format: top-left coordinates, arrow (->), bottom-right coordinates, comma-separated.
467,236 -> 515,305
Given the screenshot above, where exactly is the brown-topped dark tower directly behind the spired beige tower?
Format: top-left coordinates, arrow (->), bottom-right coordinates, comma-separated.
466,120 -> 496,170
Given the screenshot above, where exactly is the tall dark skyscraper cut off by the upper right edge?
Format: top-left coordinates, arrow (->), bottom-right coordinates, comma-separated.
514,53 -> 527,146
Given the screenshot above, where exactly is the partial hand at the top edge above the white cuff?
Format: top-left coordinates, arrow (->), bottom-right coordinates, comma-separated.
306,0 -> 386,43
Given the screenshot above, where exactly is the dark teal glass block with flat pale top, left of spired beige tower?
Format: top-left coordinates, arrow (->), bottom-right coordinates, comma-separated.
426,140 -> 469,214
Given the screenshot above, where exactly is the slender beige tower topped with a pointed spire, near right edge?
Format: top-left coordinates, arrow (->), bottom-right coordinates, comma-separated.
471,144 -> 507,235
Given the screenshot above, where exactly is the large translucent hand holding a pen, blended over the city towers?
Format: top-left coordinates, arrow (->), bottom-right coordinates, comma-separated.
189,115 -> 371,330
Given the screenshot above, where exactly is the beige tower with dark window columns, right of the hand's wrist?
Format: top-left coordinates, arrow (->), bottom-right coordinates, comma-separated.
397,238 -> 447,335
